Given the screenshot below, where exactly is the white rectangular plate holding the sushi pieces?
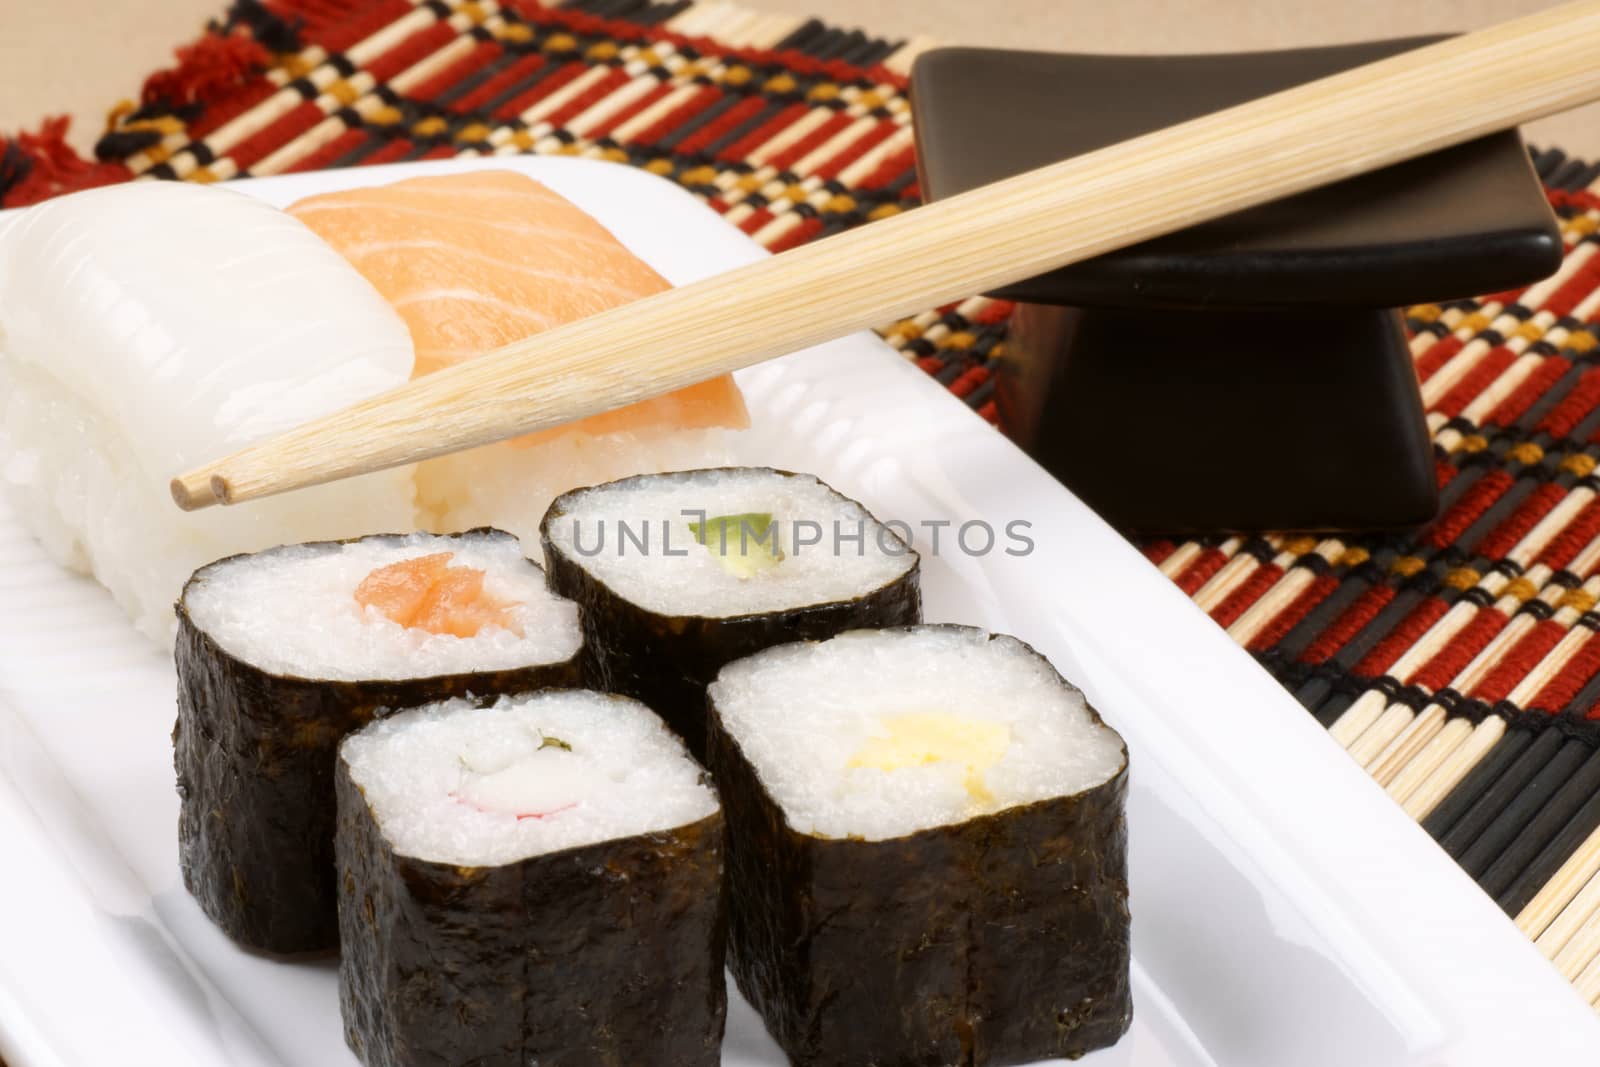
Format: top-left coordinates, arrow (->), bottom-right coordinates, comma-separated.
0,157 -> 1600,1067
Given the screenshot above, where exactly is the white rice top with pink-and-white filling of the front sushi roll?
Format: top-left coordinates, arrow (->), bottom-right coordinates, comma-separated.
339,689 -> 717,867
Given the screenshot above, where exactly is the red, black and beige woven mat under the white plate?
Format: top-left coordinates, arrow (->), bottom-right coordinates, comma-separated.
0,0 -> 1600,1011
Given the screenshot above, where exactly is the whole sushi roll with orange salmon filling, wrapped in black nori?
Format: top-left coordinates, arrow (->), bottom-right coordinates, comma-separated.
173,530 -> 586,953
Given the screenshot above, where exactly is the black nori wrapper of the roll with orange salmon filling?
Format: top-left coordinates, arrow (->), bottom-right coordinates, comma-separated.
173,530 -> 587,955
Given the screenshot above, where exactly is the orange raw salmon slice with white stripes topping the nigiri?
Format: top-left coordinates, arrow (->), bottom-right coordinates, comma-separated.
290,170 -> 750,440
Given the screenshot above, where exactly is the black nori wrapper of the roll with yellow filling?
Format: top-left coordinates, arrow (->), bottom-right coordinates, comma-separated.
707,630 -> 1133,1067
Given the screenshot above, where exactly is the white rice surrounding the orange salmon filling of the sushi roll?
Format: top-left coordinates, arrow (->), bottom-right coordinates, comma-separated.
184,533 -> 582,681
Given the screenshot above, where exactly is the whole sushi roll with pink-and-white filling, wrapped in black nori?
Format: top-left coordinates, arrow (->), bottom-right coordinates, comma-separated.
338,691 -> 726,1067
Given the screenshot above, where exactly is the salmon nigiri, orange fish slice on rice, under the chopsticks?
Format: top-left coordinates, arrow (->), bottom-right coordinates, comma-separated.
290,163 -> 749,544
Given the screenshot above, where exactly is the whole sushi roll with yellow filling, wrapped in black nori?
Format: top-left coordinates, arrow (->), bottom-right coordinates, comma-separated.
709,625 -> 1133,1067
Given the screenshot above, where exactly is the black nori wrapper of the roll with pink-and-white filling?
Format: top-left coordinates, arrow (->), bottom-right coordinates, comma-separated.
336,748 -> 728,1067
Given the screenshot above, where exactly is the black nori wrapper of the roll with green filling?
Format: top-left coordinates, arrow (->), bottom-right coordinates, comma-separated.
539,469 -> 922,760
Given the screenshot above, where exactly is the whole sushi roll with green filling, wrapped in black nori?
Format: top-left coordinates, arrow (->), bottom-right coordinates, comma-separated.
539,467 -> 922,757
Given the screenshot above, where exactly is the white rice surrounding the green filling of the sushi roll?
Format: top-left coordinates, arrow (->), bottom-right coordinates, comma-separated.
547,467 -> 917,617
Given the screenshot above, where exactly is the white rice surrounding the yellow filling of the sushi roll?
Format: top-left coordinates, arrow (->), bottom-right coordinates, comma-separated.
709,627 -> 1126,841
